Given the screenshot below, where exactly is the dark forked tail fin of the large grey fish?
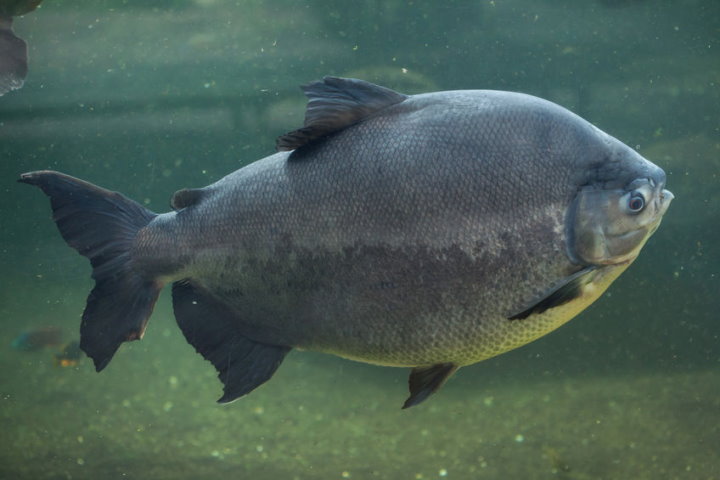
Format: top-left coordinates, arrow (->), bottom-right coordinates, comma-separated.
19,171 -> 162,372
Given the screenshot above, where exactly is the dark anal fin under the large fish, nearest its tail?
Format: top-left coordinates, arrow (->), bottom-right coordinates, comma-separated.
173,281 -> 290,403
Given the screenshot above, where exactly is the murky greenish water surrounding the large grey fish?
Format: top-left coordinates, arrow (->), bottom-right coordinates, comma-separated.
0,0 -> 720,480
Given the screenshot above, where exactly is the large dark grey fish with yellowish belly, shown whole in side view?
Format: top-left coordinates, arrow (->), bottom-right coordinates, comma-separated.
19,77 -> 673,408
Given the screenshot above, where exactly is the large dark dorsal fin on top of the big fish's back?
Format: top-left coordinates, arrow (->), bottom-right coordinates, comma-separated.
277,77 -> 408,151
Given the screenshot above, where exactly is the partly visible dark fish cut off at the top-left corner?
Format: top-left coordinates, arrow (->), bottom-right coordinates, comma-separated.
0,0 -> 42,97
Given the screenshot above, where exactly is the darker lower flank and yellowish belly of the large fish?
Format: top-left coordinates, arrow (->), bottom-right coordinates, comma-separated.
184,238 -> 608,366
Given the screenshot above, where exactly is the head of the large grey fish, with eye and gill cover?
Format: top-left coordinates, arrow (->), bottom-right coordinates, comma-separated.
568,135 -> 674,265
